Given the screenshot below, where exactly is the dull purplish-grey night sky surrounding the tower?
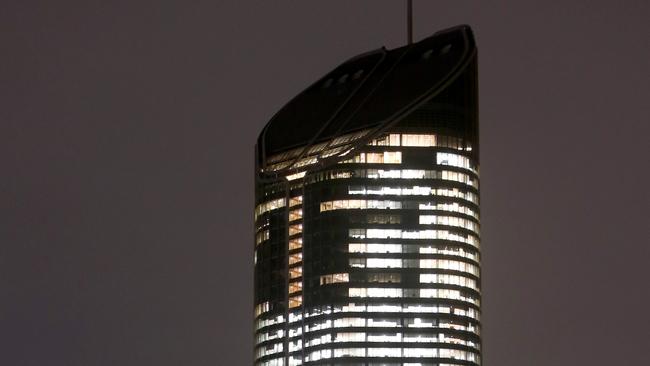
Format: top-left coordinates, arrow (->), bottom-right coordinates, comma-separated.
0,0 -> 650,366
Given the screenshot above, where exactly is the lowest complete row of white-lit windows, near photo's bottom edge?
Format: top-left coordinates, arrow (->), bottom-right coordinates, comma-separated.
305,347 -> 480,362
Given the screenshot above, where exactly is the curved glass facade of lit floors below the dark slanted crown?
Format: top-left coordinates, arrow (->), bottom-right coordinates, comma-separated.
255,129 -> 481,366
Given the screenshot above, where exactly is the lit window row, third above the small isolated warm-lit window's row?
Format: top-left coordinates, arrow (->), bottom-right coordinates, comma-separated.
348,229 -> 480,248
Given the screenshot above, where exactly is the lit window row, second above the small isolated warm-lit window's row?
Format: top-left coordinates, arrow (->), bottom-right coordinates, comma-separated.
348,243 -> 479,262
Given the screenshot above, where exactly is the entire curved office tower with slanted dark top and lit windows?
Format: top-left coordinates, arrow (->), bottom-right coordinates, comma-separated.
254,26 -> 481,366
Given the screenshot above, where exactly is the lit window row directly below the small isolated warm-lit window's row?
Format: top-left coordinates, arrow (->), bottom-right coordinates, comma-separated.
348,287 -> 480,306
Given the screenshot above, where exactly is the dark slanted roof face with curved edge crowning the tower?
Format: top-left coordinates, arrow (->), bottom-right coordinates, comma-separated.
256,25 -> 477,174
